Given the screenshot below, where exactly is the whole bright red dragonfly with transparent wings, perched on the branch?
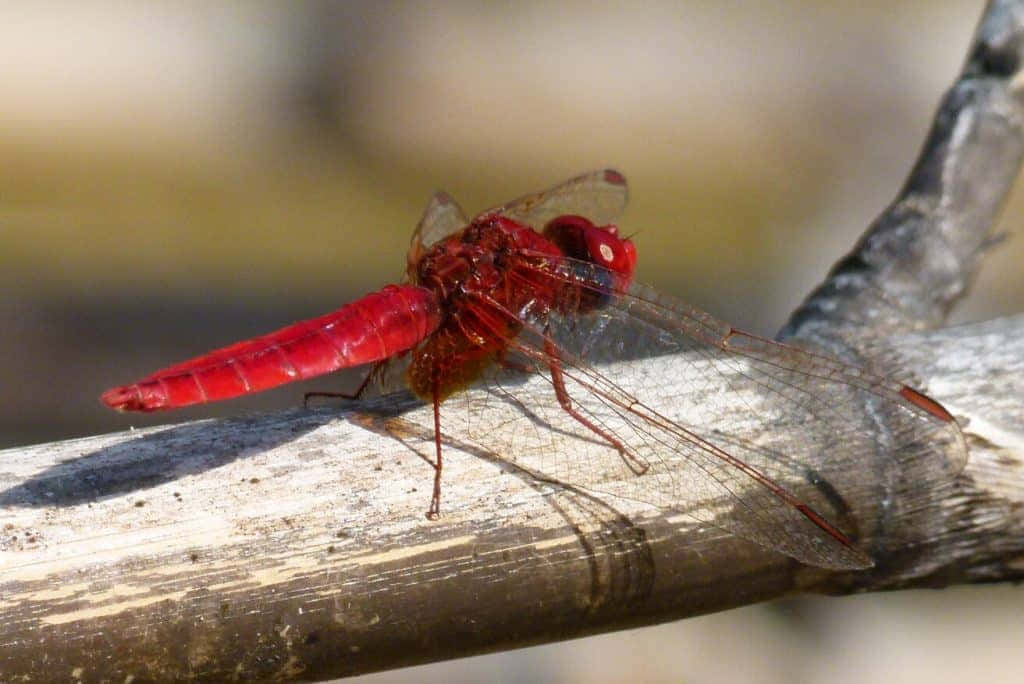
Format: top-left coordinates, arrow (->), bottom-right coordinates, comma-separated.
101,169 -> 966,568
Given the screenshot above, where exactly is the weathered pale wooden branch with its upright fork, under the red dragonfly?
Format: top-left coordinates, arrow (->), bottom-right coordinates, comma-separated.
0,2 -> 1024,681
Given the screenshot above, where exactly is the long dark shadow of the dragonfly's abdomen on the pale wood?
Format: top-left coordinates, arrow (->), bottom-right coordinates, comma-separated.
0,409 -> 338,508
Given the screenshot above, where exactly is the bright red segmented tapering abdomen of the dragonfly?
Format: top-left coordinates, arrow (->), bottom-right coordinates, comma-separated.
100,285 -> 441,411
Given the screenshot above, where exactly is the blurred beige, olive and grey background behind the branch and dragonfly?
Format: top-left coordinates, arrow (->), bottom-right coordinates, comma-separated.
0,0 -> 1024,682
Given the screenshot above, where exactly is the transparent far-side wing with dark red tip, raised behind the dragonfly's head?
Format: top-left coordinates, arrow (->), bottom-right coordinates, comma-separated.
478,169 -> 629,230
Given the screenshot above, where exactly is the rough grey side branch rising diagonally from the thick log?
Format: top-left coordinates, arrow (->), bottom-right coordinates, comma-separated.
780,0 -> 1024,351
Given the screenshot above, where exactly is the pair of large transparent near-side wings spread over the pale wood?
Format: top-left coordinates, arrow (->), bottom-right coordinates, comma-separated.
421,255 -> 967,568
